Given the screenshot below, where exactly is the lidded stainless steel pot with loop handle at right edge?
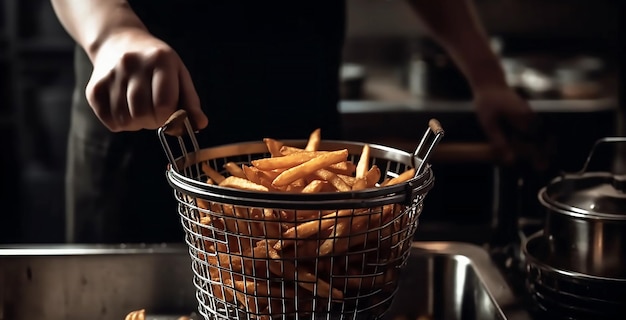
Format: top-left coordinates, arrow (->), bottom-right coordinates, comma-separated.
538,137 -> 626,279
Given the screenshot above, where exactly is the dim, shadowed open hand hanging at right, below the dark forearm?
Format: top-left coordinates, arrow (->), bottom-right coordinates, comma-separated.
474,86 -> 547,170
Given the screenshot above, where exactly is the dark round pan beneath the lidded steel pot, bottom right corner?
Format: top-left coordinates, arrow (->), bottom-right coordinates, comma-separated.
523,232 -> 626,320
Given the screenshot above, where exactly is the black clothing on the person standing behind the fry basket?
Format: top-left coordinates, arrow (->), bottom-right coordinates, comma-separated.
66,0 -> 345,243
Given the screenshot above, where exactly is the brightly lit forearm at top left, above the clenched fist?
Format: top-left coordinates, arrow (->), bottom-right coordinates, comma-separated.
51,0 -> 146,61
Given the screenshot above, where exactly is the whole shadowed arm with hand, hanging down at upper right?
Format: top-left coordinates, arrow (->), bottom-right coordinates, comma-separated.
408,0 -> 545,168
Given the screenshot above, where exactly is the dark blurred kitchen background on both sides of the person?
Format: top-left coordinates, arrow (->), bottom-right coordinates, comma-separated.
0,0 -> 624,243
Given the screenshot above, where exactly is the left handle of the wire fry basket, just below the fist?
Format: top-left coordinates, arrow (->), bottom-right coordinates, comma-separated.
157,109 -> 200,172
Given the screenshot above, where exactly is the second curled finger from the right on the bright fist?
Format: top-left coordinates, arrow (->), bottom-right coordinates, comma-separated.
126,73 -> 153,129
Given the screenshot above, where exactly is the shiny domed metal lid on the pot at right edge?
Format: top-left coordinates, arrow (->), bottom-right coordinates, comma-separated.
543,172 -> 626,219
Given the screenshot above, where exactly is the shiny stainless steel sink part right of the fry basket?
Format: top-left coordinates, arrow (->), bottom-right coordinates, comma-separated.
386,242 -> 531,320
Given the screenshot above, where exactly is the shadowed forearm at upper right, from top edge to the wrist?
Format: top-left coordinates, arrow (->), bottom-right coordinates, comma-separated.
409,0 -> 506,91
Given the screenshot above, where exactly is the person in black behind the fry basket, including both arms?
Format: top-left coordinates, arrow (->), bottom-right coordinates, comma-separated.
51,0 -> 533,243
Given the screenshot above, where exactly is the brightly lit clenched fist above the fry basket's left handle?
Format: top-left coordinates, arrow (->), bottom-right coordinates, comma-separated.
85,29 -> 208,132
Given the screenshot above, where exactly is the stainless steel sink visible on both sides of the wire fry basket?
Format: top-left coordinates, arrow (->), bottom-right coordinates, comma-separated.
0,242 -> 530,320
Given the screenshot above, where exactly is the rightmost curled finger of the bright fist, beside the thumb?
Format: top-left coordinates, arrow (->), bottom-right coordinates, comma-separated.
152,65 -> 179,126
